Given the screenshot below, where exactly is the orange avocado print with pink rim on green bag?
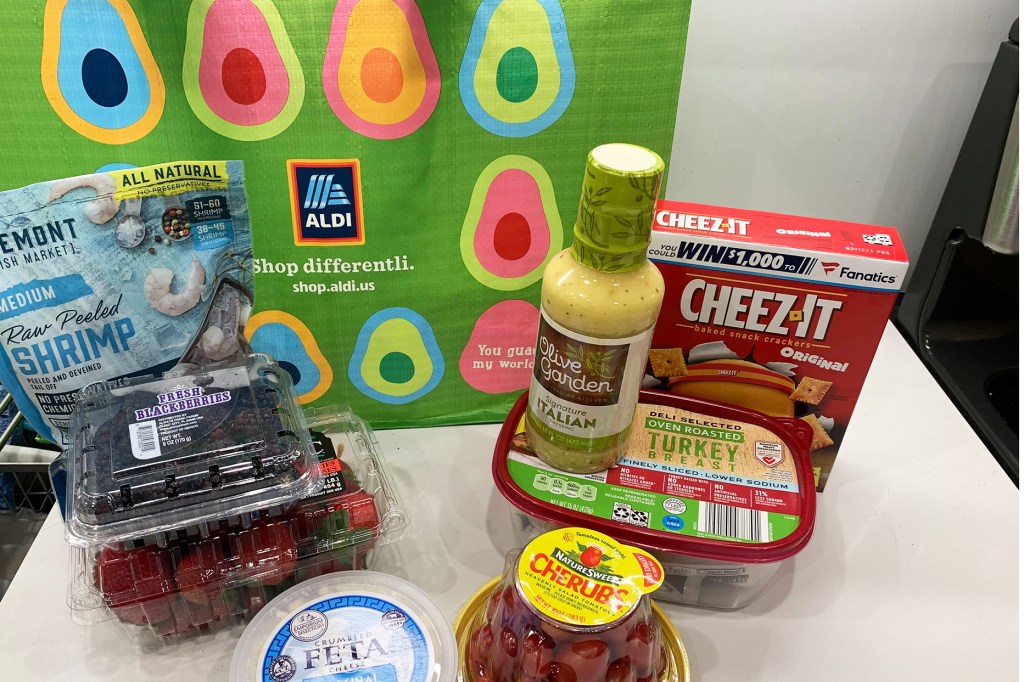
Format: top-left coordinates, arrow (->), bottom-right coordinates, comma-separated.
324,0 -> 441,139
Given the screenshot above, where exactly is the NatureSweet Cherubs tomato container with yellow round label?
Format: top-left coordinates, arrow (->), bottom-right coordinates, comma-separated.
455,527 -> 689,682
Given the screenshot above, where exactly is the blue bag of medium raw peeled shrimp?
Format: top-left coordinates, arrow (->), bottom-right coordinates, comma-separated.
0,161 -> 252,443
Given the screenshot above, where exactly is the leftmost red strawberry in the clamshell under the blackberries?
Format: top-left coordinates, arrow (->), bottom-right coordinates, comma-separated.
93,547 -> 177,625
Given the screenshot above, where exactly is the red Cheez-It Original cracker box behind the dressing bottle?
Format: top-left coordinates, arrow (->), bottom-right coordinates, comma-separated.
645,201 -> 907,491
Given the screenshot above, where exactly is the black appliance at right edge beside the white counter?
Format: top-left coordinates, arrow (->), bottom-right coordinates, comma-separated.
894,19 -> 1020,486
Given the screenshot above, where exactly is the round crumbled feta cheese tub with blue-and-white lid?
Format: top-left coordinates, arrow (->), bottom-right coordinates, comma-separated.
228,570 -> 456,682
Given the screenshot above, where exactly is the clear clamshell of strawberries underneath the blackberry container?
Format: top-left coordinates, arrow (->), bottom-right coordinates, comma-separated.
61,395 -> 409,644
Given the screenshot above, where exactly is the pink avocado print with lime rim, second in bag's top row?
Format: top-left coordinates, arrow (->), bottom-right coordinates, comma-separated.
181,0 -> 305,141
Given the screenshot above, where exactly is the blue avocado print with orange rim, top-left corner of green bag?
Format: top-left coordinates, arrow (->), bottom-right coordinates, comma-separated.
40,0 -> 166,144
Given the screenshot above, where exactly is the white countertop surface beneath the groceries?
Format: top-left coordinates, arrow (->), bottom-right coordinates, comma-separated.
0,325 -> 1019,682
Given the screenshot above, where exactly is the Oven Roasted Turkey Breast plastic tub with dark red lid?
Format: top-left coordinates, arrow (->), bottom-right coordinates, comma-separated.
492,390 -> 815,608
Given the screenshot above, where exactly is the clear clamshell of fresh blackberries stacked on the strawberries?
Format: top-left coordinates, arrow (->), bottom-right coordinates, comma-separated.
65,354 -> 322,547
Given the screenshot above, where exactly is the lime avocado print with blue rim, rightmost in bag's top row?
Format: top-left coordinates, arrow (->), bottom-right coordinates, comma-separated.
459,0 -> 575,137
